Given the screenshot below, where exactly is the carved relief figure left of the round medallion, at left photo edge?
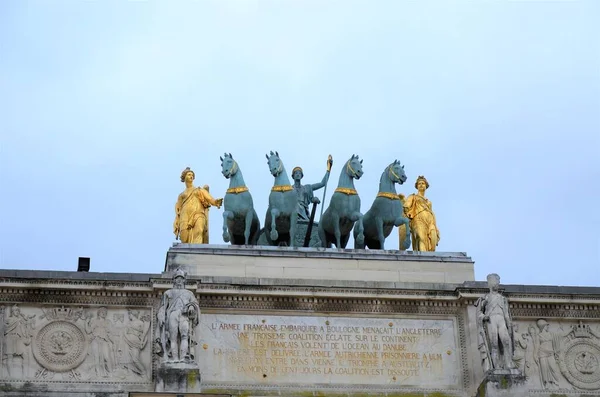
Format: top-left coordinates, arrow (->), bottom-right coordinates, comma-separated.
2,305 -> 36,379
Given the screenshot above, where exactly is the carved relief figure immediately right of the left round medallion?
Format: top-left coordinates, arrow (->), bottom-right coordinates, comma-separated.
85,307 -> 116,378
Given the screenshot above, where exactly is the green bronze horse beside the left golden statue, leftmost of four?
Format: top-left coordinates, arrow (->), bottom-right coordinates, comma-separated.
220,153 -> 260,245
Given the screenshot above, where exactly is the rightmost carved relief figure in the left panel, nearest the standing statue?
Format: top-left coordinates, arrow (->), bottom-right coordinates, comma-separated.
123,310 -> 150,377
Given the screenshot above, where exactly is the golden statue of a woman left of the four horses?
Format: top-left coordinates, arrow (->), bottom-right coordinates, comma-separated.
173,167 -> 223,244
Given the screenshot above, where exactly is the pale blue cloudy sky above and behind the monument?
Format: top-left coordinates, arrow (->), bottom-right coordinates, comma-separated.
0,0 -> 600,286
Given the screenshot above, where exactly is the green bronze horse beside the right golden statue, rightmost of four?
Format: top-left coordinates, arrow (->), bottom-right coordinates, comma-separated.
354,160 -> 410,249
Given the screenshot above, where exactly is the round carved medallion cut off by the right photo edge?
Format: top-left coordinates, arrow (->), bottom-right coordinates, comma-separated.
558,325 -> 600,390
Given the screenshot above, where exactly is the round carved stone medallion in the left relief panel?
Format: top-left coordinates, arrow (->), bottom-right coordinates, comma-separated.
33,320 -> 87,372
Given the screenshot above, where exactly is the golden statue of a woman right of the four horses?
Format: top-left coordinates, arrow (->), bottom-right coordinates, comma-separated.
400,176 -> 440,251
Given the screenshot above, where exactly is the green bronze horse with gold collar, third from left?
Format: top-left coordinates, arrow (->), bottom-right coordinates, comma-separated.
319,155 -> 364,248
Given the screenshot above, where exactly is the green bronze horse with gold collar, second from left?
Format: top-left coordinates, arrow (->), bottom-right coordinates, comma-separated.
265,152 -> 298,247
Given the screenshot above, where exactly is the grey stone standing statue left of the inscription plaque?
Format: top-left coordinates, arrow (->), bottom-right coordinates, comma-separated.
156,269 -> 200,362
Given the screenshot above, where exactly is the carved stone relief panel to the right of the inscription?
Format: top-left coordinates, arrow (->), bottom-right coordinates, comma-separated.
514,319 -> 600,391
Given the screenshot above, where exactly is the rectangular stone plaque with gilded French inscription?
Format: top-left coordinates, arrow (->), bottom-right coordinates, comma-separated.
198,313 -> 461,388
